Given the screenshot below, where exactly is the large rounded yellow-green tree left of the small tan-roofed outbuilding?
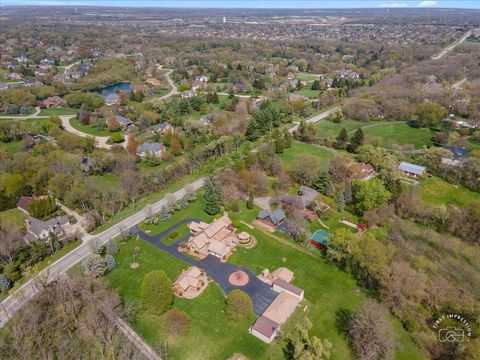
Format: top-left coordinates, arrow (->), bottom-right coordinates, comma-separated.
140,270 -> 173,315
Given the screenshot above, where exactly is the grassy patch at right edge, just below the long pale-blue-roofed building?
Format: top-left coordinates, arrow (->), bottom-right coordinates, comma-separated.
420,177 -> 480,207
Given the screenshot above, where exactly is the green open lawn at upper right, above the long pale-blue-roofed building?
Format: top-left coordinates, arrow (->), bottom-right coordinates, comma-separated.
363,123 -> 434,149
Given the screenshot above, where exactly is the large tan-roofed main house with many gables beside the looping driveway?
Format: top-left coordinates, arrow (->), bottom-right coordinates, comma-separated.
187,213 -> 239,260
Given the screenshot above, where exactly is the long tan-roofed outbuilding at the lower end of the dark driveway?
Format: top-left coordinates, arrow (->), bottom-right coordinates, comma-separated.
249,268 -> 304,344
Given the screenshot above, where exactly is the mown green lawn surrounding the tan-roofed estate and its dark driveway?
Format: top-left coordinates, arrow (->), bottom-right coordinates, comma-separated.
106,196 -> 424,360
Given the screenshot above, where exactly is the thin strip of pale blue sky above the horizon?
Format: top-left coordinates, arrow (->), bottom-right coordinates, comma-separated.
0,0 -> 480,9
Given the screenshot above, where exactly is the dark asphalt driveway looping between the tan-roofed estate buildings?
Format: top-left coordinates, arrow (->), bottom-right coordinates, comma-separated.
131,222 -> 278,316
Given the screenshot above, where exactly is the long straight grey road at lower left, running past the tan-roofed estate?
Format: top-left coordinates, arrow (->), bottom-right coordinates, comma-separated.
0,178 -> 204,328
